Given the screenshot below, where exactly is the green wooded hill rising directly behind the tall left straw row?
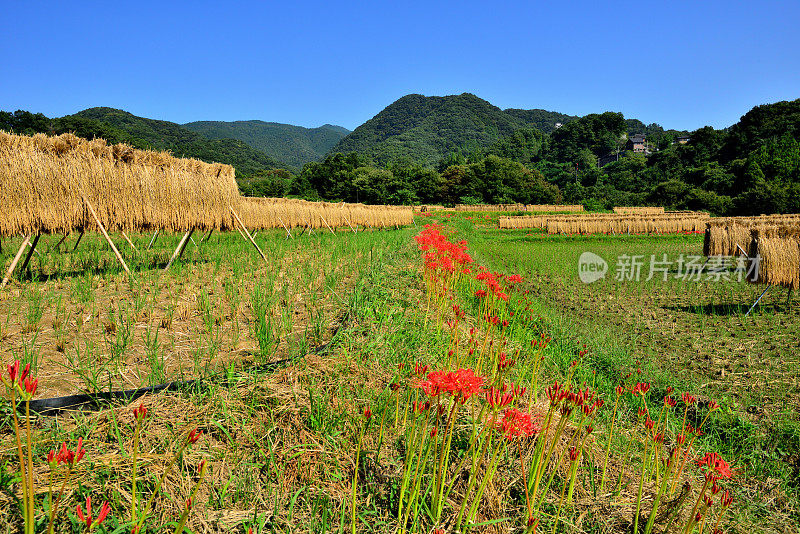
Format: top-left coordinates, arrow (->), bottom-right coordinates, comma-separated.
69,107 -> 285,177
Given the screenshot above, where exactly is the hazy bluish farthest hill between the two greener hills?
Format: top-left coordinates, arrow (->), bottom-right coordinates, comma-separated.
183,120 -> 350,170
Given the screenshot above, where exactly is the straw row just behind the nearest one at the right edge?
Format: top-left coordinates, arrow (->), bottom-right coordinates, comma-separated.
703,215 -> 800,256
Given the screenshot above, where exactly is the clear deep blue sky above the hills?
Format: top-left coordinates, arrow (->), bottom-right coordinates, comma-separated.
0,0 -> 800,130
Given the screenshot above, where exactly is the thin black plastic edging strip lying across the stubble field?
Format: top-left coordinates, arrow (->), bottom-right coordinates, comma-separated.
17,324 -> 341,416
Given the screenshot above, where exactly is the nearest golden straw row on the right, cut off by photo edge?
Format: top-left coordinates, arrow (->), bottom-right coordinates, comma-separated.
748,226 -> 800,289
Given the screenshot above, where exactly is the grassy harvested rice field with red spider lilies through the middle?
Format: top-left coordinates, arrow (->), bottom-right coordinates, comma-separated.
0,211 -> 800,533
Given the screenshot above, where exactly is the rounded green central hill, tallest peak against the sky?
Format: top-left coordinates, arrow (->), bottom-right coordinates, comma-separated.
330,93 -> 577,165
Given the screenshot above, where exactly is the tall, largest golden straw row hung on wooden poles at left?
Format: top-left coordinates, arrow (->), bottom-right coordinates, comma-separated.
0,132 -> 240,236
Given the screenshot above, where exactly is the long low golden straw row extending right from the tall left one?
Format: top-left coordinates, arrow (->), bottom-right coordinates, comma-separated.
240,198 -> 414,229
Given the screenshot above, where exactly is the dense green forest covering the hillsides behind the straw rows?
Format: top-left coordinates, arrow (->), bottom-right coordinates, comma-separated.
0,94 -> 800,215
